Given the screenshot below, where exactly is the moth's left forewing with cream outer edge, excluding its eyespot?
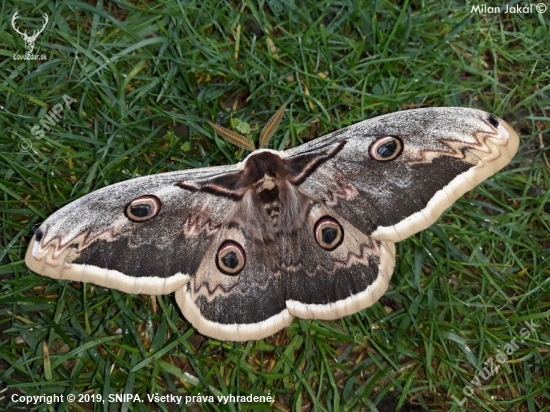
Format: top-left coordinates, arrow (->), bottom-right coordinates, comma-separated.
25,166 -> 242,294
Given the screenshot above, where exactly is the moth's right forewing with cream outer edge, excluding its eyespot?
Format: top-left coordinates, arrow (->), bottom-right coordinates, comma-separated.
287,108 -> 519,242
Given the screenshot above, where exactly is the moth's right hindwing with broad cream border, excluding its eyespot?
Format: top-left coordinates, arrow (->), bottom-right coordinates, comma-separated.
281,203 -> 395,319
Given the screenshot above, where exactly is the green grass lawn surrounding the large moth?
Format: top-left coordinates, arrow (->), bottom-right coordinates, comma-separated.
0,0 -> 550,412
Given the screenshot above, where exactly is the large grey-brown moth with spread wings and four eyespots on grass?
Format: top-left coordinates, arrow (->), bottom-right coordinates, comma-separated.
25,107 -> 519,341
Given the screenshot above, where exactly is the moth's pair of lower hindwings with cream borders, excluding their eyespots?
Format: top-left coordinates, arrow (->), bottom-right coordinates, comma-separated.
176,203 -> 395,341
